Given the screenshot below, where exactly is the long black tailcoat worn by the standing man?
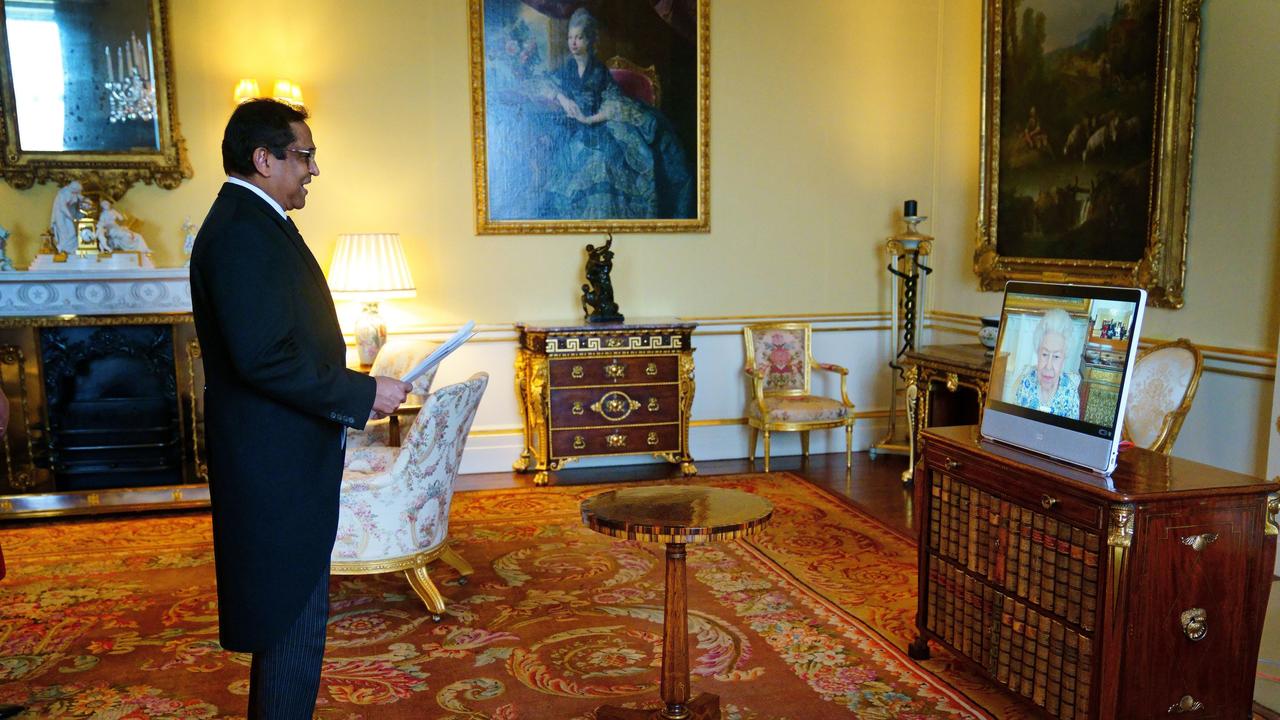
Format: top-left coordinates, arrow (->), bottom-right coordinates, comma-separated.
191,183 -> 376,652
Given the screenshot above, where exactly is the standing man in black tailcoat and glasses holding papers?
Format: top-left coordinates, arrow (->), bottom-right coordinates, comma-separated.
191,100 -> 412,720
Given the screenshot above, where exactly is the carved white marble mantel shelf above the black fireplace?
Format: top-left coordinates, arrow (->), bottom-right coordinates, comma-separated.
0,268 -> 191,316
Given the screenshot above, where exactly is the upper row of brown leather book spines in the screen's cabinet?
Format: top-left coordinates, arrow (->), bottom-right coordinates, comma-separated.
929,475 -> 1100,632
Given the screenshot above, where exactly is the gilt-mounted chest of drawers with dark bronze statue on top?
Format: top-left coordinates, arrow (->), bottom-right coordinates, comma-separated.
515,320 -> 698,486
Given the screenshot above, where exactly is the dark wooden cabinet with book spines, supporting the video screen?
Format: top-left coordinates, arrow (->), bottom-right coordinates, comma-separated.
910,427 -> 1280,720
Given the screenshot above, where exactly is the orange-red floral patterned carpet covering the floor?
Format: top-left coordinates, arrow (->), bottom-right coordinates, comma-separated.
0,473 -> 1049,720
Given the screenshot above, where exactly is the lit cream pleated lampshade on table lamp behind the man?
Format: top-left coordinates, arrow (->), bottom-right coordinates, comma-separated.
329,233 -> 417,301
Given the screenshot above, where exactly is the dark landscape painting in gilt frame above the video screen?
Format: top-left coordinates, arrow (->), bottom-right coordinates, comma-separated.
974,0 -> 1201,307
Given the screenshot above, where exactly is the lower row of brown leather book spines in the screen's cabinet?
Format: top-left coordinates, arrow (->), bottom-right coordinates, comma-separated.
927,562 -> 1093,719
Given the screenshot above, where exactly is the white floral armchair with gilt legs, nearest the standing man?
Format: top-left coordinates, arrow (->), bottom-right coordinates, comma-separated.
332,373 -> 489,621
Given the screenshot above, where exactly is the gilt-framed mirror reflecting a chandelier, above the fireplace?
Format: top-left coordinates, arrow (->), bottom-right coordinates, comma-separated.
0,0 -> 192,199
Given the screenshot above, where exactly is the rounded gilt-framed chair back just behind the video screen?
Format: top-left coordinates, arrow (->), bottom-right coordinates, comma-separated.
1120,338 -> 1204,455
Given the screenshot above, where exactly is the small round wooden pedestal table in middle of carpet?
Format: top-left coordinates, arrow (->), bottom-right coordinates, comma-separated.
581,486 -> 773,720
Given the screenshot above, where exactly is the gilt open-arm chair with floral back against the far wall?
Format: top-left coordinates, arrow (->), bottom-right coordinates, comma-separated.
742,323 -> 854,473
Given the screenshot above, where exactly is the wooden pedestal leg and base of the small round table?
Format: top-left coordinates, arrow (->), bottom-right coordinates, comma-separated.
595,542 -> 721,720
